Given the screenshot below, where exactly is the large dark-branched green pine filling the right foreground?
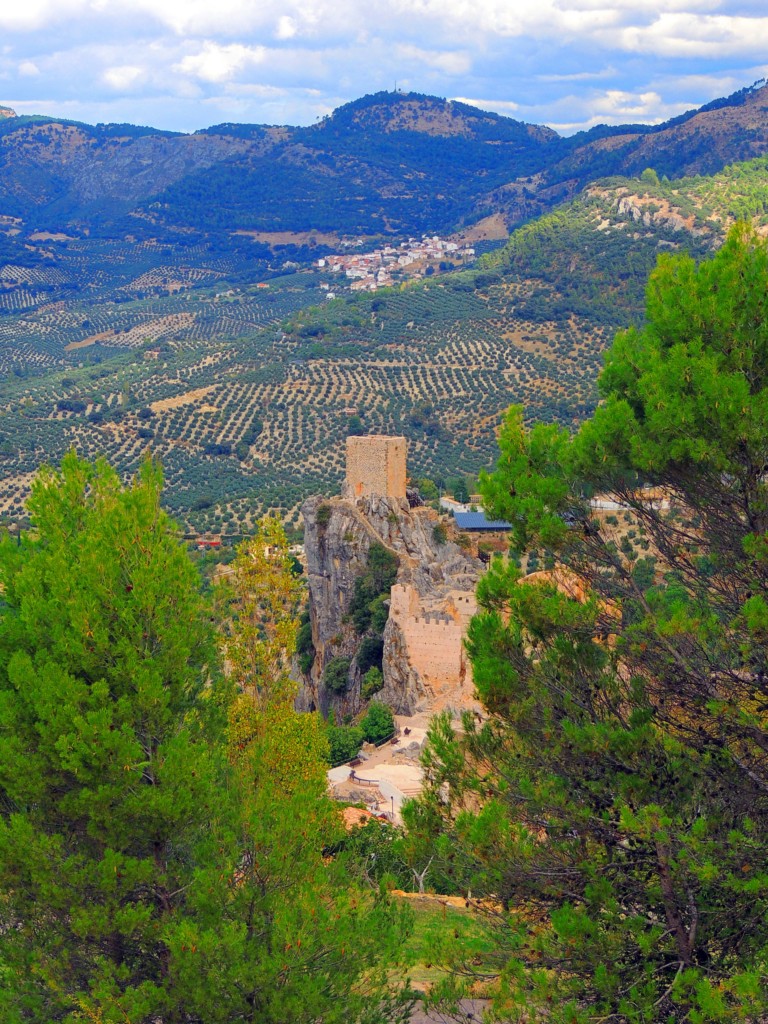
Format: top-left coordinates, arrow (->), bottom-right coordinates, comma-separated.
418,225 -> 768,1022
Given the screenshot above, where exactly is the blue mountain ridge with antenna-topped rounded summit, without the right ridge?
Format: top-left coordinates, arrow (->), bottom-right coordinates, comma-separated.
0,93 -> 558,236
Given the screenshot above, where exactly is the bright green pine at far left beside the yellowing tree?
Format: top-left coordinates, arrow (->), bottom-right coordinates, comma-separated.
0,454 -> 225,1024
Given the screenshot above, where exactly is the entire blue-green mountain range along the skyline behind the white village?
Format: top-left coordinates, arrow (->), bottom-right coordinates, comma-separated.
0,83 -> 768,240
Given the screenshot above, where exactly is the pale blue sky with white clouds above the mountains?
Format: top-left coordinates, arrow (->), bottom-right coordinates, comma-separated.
0,0 -> 768,134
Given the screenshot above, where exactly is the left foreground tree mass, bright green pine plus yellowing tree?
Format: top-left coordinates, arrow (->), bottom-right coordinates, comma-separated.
0,454 -> 410,1024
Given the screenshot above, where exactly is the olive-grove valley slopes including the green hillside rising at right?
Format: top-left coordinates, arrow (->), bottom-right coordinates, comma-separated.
7,151 -> 757,534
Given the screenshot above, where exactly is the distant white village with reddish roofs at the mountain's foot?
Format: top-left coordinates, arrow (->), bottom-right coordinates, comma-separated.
315,234 -> 475,292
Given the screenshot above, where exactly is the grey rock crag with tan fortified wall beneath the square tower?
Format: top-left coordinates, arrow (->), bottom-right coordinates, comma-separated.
299,495 -> 480,716
